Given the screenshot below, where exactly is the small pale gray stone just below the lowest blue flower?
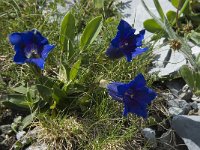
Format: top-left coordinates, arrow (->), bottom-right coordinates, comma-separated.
142,128 -> 157,147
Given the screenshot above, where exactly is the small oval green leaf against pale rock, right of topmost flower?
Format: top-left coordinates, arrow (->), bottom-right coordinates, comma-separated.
143,19 -> 163,33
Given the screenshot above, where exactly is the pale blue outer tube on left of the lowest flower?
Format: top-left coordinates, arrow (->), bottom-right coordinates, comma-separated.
107,82 -> 124,102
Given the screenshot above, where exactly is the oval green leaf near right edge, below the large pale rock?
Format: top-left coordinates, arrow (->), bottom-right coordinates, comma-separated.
180,65 -> 195,89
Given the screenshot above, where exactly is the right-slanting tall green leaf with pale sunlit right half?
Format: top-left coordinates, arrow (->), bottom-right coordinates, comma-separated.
80,16 -> 103,49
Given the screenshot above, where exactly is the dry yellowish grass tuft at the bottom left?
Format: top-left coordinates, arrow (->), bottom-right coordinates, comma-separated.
33,115 -> 86,150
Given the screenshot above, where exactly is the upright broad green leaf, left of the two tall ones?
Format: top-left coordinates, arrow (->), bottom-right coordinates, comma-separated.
60,12 -> 75,45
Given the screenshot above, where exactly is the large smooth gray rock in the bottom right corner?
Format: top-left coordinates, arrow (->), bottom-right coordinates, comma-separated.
171,115 -> 200,150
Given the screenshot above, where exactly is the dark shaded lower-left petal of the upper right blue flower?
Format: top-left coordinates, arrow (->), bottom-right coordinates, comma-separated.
106,44 -> 124,59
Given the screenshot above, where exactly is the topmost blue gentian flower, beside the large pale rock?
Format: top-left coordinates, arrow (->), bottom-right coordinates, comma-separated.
106,20 -> 148,62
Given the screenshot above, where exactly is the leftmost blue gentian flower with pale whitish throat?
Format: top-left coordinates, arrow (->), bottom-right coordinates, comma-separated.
9,30 -> 55,69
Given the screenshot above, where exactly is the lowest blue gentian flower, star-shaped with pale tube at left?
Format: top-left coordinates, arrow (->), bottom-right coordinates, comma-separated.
107,74 -> 157,118
